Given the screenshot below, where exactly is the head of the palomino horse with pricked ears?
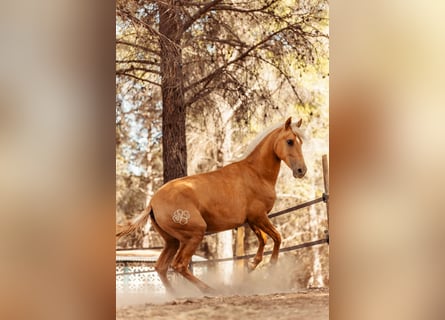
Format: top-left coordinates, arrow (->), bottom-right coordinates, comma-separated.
274,117 -> 307,178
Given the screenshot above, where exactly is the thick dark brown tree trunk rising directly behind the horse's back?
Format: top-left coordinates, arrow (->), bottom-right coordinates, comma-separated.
159,1 -> 187,183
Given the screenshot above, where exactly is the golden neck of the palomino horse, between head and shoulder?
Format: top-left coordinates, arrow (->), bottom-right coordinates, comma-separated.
241,129 -> 281,185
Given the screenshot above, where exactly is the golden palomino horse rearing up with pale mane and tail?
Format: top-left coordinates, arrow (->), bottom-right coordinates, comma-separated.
116,118 -> 306,292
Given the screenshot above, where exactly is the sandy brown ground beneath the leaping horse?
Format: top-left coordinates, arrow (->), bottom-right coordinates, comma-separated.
116,289 -> 329,320
